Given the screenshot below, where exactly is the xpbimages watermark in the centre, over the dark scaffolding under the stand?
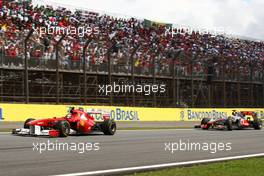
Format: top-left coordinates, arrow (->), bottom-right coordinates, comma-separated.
99,82 -> 166,95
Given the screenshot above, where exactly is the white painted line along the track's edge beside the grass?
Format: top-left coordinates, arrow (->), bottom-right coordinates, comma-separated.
51,153 -> 264,176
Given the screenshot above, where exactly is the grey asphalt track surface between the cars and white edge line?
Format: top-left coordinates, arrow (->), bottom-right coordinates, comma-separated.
0,129 -> 264,176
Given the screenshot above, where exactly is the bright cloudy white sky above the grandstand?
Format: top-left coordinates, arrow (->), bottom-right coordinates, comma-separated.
33,0 -> 264,40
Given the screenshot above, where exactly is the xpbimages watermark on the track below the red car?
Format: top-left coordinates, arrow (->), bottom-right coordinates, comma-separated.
32,140 -> 100,154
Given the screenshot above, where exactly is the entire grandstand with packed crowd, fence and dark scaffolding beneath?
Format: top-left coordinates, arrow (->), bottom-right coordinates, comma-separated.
0,0 -> 264,107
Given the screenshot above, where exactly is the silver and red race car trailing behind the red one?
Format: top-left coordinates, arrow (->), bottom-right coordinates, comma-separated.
195,110 -> 262,131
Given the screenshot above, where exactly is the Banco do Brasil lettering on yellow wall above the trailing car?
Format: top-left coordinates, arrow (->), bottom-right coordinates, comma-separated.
187,110 -> 228,120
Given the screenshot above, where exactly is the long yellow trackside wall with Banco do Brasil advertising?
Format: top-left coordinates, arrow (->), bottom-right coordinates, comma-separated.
0,104 -> 264,121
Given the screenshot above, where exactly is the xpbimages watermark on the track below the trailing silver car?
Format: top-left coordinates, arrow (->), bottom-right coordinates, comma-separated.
164,139 -> 232,154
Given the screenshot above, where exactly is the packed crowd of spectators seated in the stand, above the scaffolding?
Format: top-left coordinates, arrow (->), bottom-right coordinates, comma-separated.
0,0 -> 264,80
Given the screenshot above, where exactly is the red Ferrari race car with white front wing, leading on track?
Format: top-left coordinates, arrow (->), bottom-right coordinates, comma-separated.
12,108 -> 116,137
